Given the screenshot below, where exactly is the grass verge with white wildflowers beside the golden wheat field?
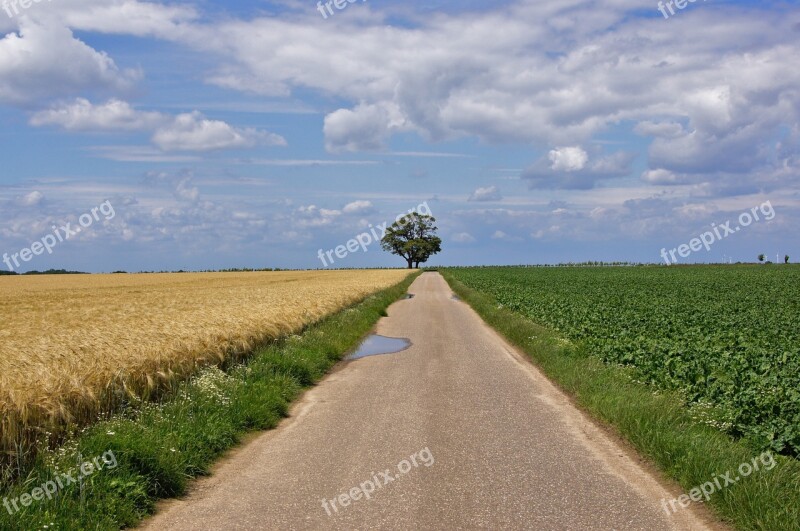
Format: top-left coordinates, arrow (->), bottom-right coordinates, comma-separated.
0,275 -> 417,530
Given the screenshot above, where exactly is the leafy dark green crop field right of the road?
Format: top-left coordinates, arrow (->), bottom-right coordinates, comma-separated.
451,266 -> 800,456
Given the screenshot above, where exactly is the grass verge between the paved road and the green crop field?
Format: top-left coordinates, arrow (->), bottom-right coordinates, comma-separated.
440,270 -> 800,531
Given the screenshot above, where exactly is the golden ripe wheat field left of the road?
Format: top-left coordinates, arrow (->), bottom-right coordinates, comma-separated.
0,270 -> 408,458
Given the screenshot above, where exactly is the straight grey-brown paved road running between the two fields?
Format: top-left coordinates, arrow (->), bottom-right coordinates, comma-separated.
145,273 -> 716,531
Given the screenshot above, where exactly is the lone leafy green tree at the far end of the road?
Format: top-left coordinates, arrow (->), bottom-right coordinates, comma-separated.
381,212 -> 442,269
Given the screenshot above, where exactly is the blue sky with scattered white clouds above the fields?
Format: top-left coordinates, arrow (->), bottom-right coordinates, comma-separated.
0,0 -> 800,272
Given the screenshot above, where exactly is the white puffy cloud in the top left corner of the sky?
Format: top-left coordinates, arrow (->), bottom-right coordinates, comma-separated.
0,0 -> 199,108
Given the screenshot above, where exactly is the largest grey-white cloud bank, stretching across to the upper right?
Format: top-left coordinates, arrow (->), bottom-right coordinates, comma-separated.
161,0 -> 800,195
